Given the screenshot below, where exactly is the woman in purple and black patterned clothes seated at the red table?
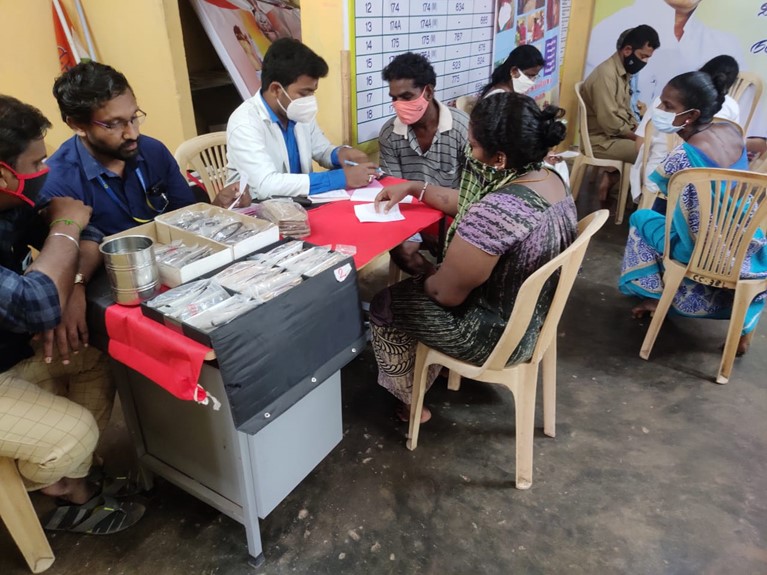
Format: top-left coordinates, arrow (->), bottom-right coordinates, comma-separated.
370,92 -> 577,422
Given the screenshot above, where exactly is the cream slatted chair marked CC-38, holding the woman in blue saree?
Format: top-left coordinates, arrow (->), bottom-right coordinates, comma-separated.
639,168 -> 767,383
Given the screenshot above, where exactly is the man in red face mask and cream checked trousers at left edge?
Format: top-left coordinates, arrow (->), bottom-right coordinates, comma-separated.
0,95 -> 143,533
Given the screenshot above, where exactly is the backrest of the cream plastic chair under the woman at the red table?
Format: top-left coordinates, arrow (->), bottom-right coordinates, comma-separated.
483,210 -> 610,370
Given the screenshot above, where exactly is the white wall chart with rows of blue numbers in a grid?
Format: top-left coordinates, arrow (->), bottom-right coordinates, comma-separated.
350,0 -> 494,144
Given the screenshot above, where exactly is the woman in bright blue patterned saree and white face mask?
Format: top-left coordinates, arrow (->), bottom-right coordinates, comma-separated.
619,72 -> 767,355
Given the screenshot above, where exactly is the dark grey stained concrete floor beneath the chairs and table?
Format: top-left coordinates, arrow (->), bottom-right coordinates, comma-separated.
0,212 -> 767,575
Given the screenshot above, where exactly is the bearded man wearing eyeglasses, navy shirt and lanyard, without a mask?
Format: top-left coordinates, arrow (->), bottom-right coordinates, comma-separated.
40,62 -> 250,362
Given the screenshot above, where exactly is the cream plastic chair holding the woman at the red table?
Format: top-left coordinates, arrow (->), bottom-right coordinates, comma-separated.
407,210 -> 610,489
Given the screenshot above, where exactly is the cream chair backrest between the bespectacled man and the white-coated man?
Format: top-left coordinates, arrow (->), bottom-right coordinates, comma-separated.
174,132 -> 227,201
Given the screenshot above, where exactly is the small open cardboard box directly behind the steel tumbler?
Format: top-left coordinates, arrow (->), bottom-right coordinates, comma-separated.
104,222 -> 234,288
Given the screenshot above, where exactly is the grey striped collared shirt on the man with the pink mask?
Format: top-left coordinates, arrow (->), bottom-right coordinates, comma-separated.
378,102 -> 469,189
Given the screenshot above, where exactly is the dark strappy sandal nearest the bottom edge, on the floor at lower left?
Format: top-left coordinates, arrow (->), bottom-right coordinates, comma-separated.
45,495 -> 146,535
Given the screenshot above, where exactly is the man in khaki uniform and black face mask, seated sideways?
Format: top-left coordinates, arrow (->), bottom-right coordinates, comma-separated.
581,24 -> 660,201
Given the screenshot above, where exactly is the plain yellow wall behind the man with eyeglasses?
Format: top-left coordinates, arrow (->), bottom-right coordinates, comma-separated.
0,0 -> 196,154
